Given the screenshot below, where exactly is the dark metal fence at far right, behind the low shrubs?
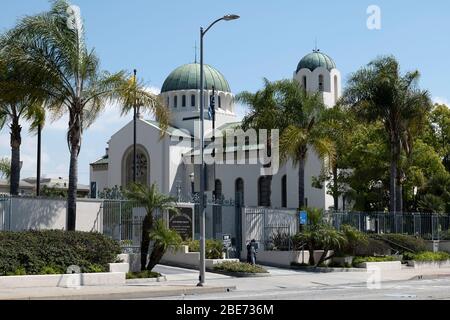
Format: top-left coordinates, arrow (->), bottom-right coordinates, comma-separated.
324,212 -> 450,240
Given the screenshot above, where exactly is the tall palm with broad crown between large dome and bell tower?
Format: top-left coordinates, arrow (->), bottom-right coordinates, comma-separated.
237,80 -> 334,208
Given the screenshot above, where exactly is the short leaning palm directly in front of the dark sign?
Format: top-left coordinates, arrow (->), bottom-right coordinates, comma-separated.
147,219 -> 182,271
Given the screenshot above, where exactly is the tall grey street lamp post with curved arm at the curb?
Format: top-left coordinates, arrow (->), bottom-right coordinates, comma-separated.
197,14 -> 239,287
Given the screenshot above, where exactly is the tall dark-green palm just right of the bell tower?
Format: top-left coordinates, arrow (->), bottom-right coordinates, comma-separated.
342,56 -> 431,212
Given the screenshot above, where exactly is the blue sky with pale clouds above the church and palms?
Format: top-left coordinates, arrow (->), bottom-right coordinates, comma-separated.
0,0 -> 450,184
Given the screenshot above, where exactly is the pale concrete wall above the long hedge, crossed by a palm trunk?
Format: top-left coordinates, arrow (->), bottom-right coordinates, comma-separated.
5,198 -> 102,232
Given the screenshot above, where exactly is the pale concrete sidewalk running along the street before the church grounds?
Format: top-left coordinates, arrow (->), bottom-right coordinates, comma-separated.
0,267 -> 450,300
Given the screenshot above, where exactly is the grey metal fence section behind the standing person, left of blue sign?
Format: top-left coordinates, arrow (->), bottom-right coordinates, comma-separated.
243,208 -> 299,251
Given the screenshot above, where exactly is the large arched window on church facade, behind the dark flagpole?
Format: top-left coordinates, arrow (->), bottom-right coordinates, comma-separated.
123,147 -> 150,186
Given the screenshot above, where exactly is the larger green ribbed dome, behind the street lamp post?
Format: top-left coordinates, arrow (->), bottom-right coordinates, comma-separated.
161,63 -> 231,92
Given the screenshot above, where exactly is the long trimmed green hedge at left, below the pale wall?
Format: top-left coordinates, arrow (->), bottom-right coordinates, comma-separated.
0,230 -> 121,275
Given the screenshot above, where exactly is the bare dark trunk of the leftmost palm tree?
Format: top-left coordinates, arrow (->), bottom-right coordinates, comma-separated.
10,117 -> 22,196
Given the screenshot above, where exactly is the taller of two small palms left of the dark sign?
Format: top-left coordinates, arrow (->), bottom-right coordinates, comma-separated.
124,184 -> 178,270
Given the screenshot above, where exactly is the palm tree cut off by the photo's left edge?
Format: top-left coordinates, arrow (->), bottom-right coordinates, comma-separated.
0,50 -> 43,196
